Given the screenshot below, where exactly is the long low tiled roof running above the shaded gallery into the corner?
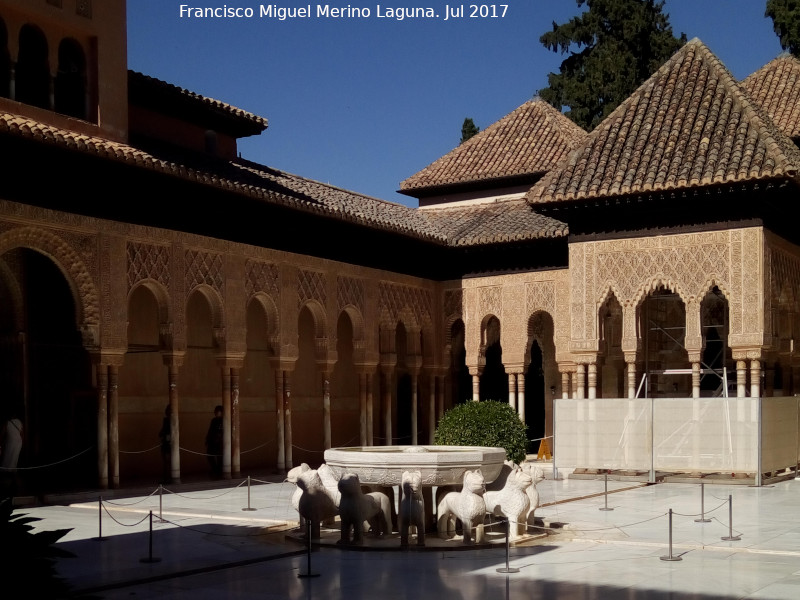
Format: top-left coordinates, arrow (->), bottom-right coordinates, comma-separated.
0,113 -> 565,246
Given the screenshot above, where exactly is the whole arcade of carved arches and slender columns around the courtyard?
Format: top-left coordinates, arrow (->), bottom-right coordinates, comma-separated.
0,201 -> 800,486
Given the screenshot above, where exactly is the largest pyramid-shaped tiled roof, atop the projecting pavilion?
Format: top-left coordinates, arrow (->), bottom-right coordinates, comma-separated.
527,39 -> 800,203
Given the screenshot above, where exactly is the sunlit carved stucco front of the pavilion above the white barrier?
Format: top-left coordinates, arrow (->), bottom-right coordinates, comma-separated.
570,227 -> 765,354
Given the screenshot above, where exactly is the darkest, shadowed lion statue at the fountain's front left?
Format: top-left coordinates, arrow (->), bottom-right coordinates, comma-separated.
338,473 -> 392,544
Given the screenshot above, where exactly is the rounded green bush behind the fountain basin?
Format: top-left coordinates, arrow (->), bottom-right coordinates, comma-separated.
435,400 -> 528,463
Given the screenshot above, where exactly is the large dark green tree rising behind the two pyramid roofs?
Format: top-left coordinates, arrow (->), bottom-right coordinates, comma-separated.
539,0 -> 686,129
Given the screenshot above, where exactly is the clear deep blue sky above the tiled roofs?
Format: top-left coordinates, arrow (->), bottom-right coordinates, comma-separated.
128,0 -> 781,206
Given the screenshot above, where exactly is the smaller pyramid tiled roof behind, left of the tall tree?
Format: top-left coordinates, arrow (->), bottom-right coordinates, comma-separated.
400,100 -> 586,195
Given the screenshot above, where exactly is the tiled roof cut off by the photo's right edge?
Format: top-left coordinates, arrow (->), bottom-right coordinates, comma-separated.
742,54 -> 800,138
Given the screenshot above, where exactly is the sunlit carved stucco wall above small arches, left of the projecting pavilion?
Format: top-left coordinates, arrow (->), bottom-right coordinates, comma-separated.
454,269 -> 570,369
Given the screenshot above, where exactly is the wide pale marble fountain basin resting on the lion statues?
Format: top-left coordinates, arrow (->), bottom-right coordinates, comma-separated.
325,446 -> 506,486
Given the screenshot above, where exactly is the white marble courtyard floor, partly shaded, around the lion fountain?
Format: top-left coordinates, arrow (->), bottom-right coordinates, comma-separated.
21,479 -> 800,600
